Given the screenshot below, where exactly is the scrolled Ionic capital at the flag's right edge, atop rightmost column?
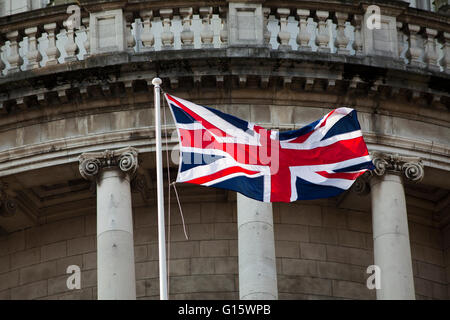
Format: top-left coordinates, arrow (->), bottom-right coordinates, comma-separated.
371,152 -> 424,182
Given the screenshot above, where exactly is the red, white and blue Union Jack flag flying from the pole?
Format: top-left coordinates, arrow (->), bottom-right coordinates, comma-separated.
165,94 -> 374,202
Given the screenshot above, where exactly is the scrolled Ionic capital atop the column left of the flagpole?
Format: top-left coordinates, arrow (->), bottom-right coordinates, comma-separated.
78,147 -> 138,180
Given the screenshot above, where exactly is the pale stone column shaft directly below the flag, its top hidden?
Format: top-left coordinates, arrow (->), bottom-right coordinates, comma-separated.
237,193 -> 278,300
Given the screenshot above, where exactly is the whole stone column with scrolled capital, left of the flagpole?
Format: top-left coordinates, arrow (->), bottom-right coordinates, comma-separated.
79,147 -> 138,300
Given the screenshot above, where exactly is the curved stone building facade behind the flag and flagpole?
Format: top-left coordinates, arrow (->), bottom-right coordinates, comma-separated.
0,0 -> 450,299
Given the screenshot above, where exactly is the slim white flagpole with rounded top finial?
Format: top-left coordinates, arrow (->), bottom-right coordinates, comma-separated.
152,78 -> 168,300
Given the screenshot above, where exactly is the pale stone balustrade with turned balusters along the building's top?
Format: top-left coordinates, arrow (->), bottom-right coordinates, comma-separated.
0,1 -> 450,77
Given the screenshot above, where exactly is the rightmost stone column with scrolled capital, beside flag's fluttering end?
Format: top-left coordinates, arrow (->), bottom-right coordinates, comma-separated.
370,153 -> 424,300
